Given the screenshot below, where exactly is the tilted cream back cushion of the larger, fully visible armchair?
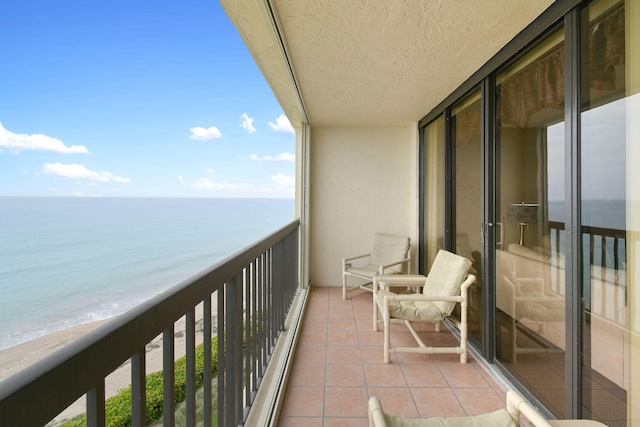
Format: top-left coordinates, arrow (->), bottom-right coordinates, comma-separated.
422,249 -> 471,316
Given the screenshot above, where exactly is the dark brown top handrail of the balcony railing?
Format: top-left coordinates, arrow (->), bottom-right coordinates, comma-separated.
0,219 -> 300,423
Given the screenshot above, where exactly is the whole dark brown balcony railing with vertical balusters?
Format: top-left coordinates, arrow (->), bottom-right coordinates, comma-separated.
0,220 -> 299,426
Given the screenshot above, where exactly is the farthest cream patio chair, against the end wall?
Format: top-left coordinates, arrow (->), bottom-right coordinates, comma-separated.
342,233 -> 411,299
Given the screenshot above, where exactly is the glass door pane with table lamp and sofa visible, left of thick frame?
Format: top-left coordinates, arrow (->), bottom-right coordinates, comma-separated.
495,27 -> 566,418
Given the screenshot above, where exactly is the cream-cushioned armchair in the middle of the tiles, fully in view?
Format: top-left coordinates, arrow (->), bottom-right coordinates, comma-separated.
373,250 -> 476,363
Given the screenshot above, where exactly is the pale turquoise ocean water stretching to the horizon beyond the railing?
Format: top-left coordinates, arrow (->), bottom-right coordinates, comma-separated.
0,197 -> 294,350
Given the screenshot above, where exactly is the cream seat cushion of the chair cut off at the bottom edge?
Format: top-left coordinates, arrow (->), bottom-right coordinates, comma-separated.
384,409 -> 517,427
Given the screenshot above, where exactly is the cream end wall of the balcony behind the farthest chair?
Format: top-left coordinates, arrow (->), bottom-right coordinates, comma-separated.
310,124 -> 418,286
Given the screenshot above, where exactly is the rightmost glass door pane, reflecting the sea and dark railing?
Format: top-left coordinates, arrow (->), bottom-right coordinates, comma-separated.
580,0 -> 640,425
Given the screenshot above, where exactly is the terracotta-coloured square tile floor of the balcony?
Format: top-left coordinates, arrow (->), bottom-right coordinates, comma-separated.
279,287 -> 505,427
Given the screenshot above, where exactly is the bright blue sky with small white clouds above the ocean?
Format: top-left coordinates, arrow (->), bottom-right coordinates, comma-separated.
0,0 -> 295,198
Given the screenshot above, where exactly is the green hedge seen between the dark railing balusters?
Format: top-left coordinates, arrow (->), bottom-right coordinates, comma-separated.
62,337 -> 218,427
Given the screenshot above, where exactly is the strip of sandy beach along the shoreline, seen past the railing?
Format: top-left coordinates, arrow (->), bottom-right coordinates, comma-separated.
0,306 -> 206,425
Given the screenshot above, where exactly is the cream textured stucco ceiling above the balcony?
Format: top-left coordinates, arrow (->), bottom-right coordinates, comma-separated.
221,0 -> 553,127
